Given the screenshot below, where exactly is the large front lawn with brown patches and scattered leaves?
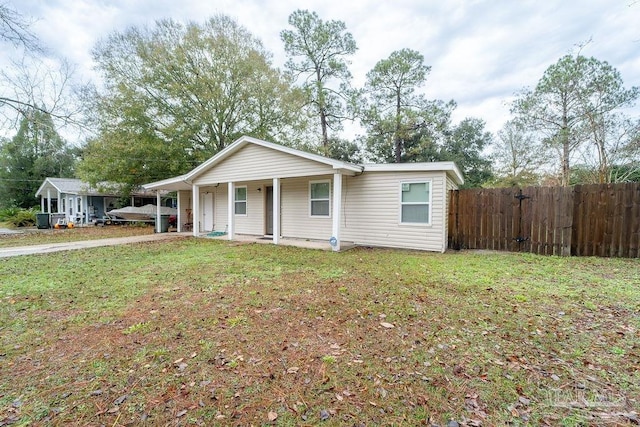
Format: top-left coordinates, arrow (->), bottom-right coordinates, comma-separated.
0,239 -> 640,426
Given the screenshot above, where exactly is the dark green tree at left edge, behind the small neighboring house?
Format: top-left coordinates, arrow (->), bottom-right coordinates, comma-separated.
0,110 -> 77,209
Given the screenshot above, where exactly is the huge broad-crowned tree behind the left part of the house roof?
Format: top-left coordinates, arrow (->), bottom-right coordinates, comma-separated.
80,15 -> 307,191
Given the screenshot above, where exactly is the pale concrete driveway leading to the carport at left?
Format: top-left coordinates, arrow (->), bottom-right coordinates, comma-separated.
0,233 -> 192,258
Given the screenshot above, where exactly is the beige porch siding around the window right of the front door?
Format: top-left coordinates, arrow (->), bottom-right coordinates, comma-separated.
280,175 -> 333,241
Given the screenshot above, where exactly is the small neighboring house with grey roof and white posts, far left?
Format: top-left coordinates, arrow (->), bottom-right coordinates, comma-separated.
36,178 -> 168,224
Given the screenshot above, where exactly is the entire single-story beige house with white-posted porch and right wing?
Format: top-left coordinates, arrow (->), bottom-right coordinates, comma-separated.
143,136 -> 464,252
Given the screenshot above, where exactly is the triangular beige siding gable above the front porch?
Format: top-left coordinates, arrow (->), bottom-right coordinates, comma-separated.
194,144 -> 333,185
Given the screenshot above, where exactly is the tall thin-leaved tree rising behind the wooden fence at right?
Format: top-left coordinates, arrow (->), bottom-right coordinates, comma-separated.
512,55 -> 638,185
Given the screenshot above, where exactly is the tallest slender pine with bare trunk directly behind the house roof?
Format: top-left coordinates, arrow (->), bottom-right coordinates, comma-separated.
280,10 -> 357,154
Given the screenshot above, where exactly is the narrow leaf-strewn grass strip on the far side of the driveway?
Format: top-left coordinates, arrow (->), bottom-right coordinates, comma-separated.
0,225 -> 154,248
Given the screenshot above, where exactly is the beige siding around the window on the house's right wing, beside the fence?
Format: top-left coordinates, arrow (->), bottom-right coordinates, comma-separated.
340,172 -> 446,252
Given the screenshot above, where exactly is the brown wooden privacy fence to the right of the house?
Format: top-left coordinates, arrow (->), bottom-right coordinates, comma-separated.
449,183 -> 640,258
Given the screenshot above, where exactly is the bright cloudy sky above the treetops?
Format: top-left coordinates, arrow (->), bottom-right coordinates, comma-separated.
4,0 -> 640,137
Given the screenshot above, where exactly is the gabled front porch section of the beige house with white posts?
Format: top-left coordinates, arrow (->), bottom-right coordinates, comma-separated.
144,137 -> 362,251
